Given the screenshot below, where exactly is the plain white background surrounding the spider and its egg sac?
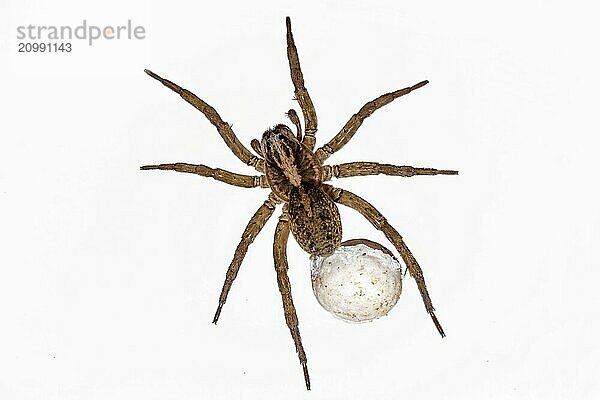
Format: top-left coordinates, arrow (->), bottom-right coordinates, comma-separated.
0,0 -> 600,399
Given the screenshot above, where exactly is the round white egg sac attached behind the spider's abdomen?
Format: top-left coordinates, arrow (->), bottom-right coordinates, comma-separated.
311,239 -> 402,322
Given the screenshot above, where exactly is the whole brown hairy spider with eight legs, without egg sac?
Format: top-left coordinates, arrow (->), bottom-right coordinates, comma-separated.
141,17 -> 458,390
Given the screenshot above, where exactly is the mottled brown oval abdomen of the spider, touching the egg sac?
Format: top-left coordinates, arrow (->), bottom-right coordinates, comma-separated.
288,185 -> 342,256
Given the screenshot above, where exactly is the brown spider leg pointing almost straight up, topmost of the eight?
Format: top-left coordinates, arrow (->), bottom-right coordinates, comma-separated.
285,17 -> 317,151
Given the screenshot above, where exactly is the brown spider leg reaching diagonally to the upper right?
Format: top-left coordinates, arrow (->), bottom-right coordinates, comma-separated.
315,81 -> 429,163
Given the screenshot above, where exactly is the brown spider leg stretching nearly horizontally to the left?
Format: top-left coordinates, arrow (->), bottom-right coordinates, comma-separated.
140,163 -> 269,188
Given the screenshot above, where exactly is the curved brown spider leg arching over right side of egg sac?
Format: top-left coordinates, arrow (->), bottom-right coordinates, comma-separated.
323,185 -> 446,337
